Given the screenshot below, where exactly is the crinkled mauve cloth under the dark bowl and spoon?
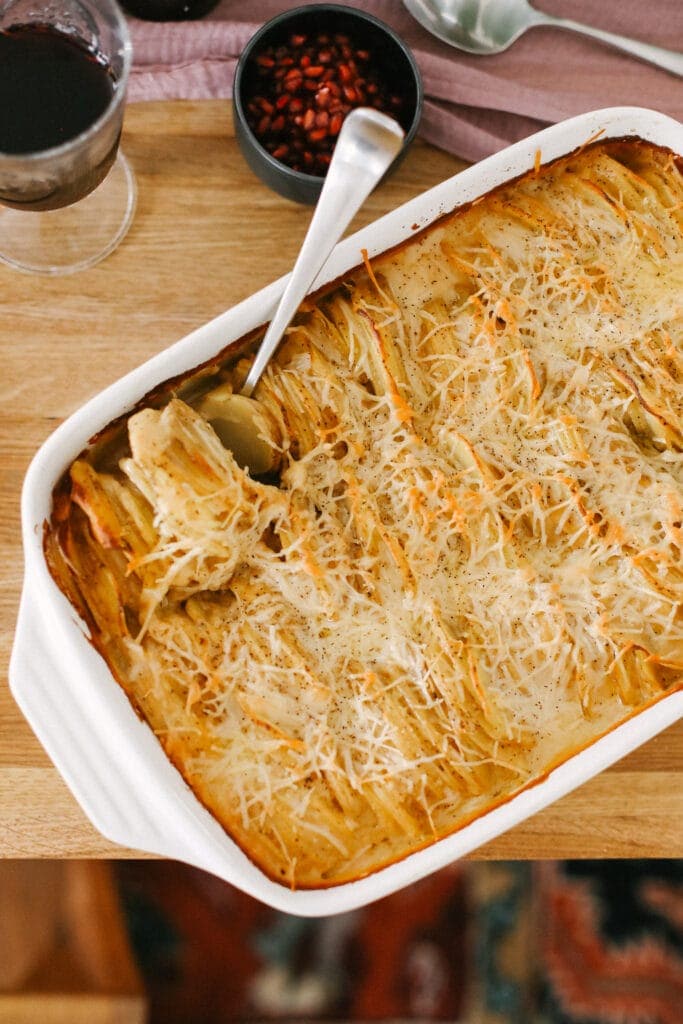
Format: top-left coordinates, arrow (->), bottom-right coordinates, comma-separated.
129,0 -> 683,161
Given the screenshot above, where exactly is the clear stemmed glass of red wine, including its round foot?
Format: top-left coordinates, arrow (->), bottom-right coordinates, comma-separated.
0,0 -> 136,274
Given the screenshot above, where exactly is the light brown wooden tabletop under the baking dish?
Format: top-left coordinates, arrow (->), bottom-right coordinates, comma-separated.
0,101 -> 683,858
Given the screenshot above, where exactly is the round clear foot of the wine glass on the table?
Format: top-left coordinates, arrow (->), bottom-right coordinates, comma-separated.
0,152 -> 137,274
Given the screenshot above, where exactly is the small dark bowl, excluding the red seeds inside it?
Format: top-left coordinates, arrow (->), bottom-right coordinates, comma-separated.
232,3 -> 423,203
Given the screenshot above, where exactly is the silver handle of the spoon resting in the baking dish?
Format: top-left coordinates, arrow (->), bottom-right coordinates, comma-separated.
242,108 -> 403,396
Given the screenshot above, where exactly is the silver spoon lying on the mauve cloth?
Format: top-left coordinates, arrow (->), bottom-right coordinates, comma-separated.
403,0 -> 683,75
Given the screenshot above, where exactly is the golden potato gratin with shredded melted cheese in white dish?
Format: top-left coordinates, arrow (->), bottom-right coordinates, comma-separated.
47,142 -> 683,887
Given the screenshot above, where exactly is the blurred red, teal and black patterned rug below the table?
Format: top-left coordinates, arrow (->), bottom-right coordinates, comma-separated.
117,861 -> 683,1024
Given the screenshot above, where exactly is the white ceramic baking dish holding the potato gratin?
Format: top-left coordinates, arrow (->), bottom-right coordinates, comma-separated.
10,108 -> 683,915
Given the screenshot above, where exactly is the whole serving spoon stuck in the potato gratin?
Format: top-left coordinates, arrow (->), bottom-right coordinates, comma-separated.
198,106 -> 404,476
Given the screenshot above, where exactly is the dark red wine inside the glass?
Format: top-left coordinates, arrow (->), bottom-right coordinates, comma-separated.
0,25 -> 118,209
